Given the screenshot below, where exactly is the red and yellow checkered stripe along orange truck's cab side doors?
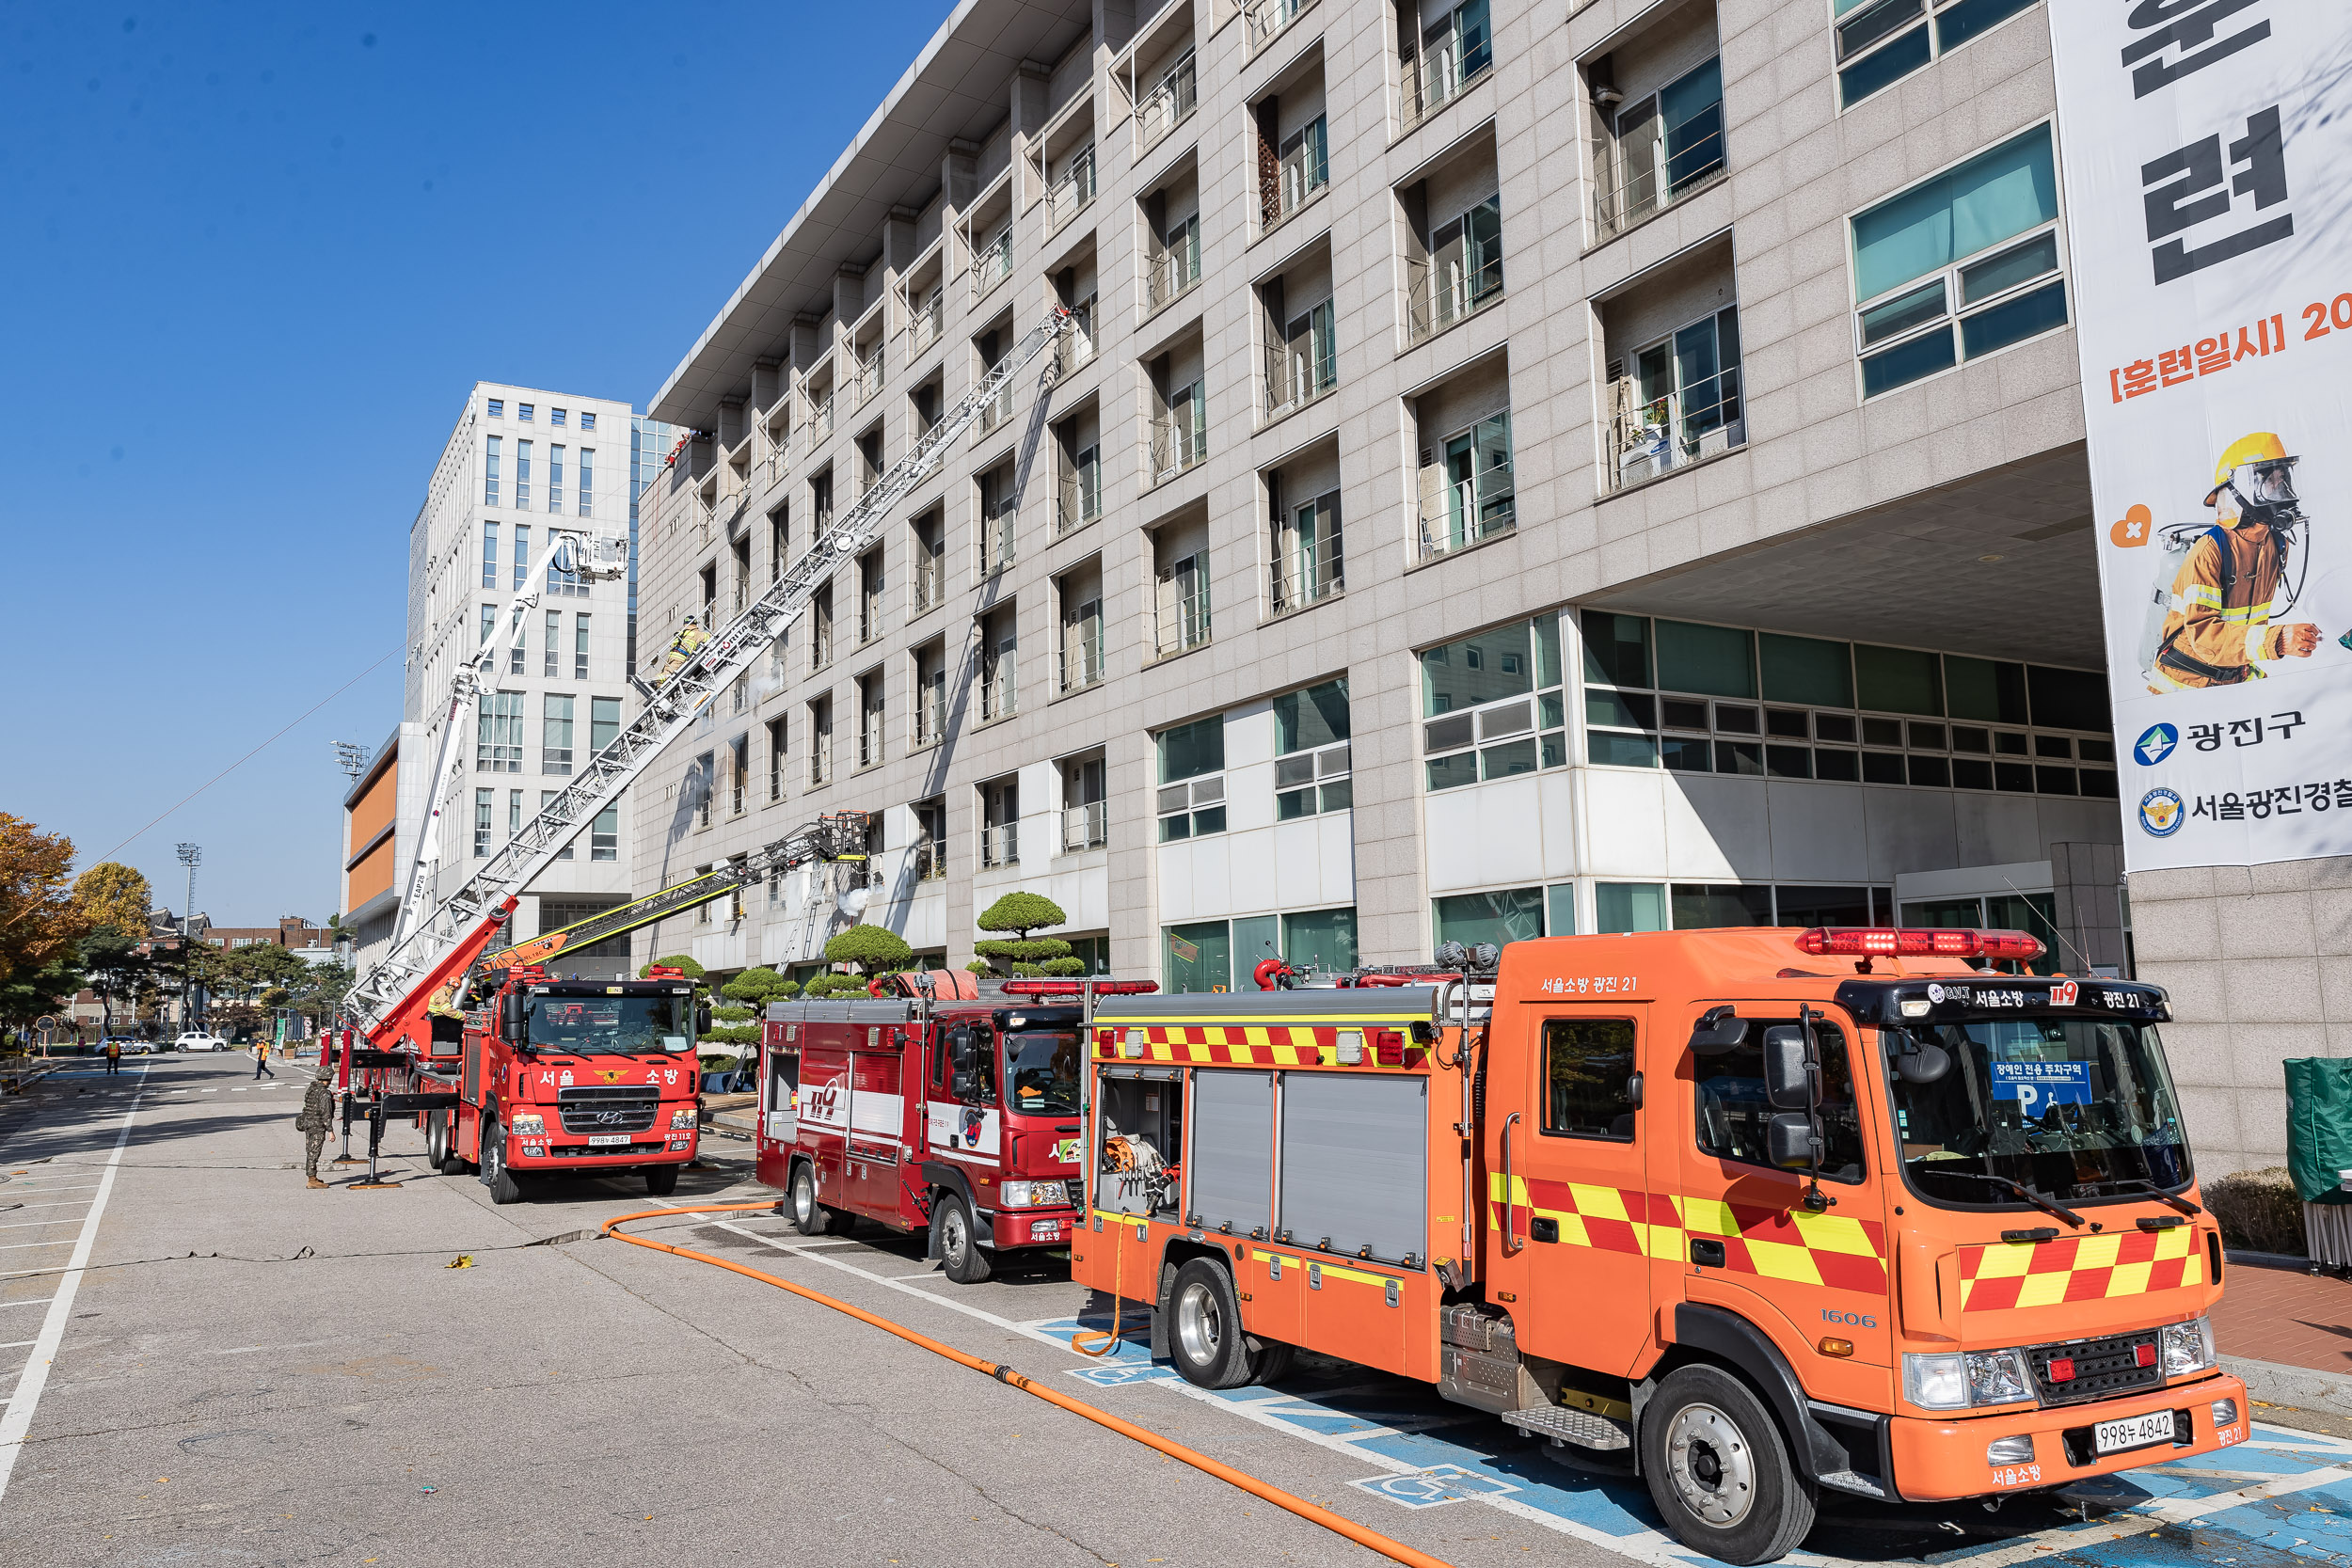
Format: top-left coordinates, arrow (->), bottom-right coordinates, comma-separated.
1486,1176 -> 1886,1293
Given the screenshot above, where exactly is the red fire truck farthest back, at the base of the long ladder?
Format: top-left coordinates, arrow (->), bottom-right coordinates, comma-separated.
392,966 -> 699,1204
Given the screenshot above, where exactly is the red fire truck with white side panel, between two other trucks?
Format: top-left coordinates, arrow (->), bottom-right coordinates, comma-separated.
755,971 -> 1155,1284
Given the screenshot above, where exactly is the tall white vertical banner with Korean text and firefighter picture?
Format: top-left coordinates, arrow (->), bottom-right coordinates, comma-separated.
2049,0 -> 2352,870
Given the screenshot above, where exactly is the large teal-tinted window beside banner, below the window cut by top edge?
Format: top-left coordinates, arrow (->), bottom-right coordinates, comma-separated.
1853,124 -> 2068,397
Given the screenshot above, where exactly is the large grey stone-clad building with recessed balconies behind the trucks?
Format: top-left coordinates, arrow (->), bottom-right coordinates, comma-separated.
638,0 -> 2324,1168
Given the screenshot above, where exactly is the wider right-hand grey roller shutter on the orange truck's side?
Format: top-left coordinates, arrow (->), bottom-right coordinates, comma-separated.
1282,1072 -> 1430,1262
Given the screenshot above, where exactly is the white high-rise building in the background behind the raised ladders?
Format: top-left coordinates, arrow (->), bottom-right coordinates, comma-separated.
402,381 -> 663,975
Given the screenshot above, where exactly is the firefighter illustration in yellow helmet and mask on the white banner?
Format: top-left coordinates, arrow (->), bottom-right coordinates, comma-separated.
2145,430 -> 2319,696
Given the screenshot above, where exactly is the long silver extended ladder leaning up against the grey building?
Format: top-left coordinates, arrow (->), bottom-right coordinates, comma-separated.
343,306 -> 1073,1030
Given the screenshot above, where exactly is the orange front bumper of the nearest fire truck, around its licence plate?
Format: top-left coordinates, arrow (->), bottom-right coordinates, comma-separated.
1886,1373 -> 2251,1502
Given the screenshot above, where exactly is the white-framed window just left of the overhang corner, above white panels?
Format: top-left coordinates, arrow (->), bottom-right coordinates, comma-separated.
1421,616 -> 1569,790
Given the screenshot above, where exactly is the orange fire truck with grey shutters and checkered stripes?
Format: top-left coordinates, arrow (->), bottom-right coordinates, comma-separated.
1073,928 -> 2247,1563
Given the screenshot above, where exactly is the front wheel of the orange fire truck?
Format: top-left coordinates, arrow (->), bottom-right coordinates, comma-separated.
1642,1366 -> 1814,1563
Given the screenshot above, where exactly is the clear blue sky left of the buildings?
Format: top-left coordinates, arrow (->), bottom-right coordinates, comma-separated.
0,0 -> 950,927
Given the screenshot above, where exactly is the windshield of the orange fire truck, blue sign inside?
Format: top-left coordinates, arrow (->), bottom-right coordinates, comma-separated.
1884,1018 -> 2190,1209
